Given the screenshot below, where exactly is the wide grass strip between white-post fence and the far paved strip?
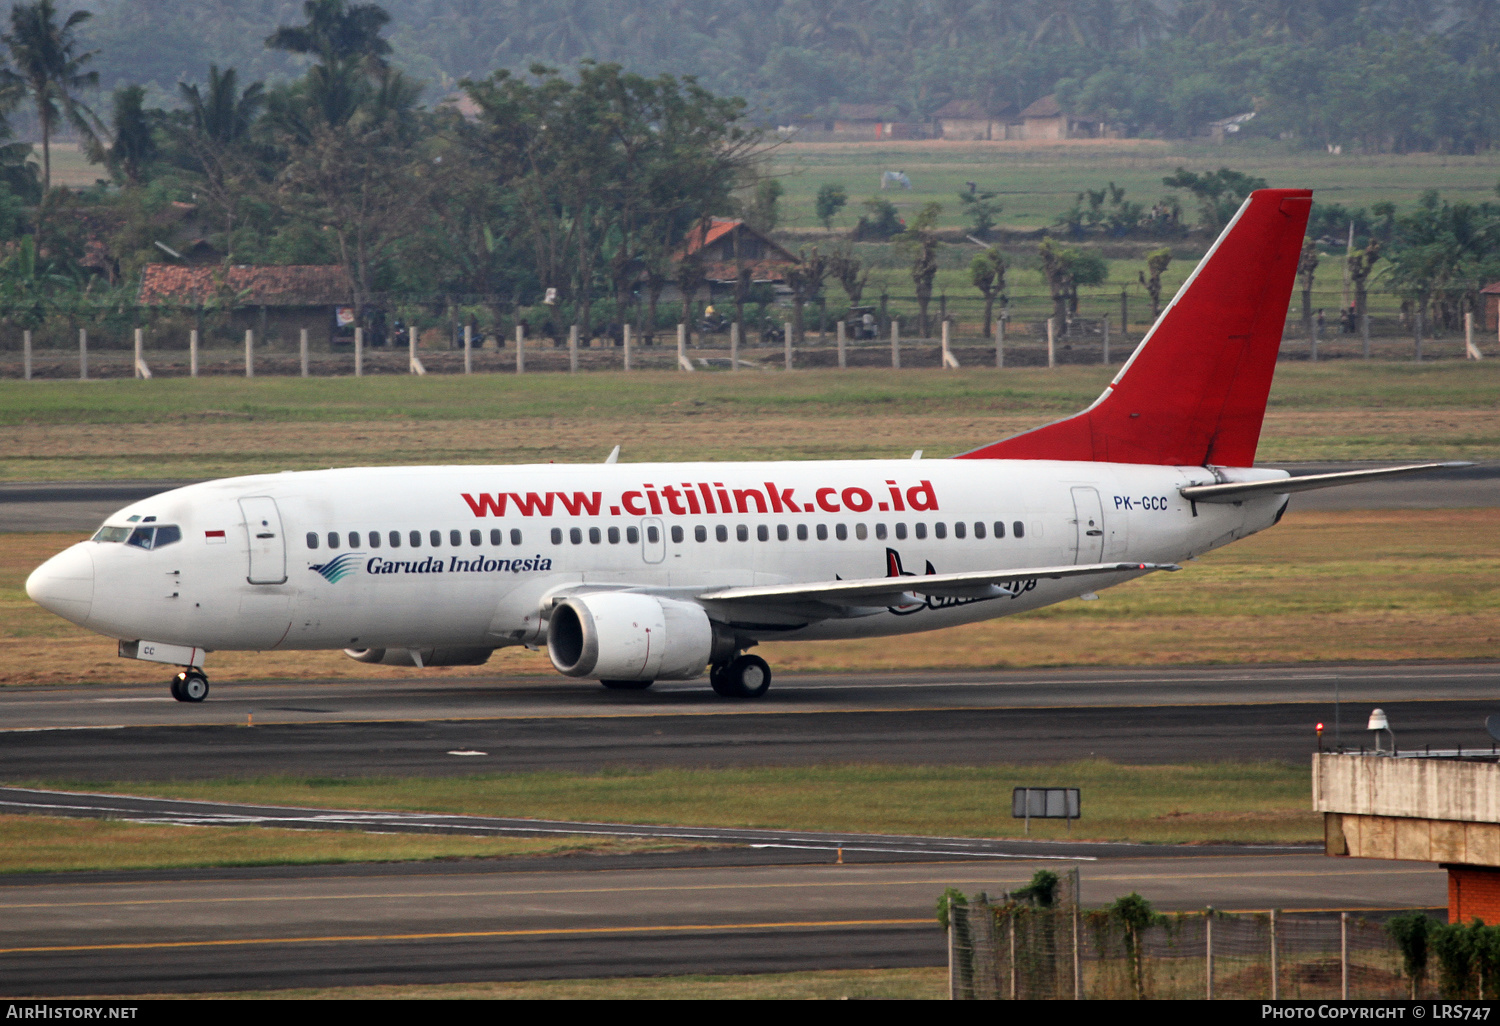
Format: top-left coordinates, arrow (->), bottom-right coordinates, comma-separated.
0,360 -> 1500,482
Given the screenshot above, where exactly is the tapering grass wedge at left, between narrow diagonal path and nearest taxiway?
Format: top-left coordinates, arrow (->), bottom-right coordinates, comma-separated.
0,816 -> 696,873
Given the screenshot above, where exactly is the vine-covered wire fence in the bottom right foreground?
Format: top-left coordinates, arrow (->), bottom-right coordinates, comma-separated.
948,894 -> 1439,1001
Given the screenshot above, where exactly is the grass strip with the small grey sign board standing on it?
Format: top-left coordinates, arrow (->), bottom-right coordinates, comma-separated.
17,762 -> 1322,843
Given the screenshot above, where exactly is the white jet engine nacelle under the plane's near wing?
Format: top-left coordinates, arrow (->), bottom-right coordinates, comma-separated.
548,591 -> 735,681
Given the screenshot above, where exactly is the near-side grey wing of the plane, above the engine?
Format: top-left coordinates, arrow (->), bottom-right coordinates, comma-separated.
698,563 -> 1182,609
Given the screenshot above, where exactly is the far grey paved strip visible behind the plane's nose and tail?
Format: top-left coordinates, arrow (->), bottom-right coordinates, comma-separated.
0,461 -> 1500,534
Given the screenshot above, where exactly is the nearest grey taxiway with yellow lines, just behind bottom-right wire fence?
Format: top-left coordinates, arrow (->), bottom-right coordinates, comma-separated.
0,855 -> 1446,996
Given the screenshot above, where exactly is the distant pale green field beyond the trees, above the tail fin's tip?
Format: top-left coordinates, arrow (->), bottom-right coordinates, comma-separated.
771,140 -> 1500,231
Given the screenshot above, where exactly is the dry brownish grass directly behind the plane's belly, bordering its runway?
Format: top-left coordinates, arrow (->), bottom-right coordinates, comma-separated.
0,510 -> 1500,686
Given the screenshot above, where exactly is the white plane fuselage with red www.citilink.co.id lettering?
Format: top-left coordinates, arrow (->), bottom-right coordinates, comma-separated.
29,461 -> 1286,650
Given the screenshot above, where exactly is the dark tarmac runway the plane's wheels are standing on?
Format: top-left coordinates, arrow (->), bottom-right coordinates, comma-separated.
0,663 -> 1500,783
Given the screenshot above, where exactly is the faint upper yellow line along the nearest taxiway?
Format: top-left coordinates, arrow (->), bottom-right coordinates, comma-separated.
0,864 -> 1443,911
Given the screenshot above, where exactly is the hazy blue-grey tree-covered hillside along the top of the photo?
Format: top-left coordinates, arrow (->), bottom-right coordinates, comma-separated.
83,0 -> 1500,152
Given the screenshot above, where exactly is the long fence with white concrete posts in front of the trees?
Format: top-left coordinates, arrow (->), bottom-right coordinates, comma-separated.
0,290 -> 1500,380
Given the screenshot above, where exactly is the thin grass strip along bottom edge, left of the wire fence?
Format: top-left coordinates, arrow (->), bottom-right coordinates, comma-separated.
132,968 -> 948,1001
